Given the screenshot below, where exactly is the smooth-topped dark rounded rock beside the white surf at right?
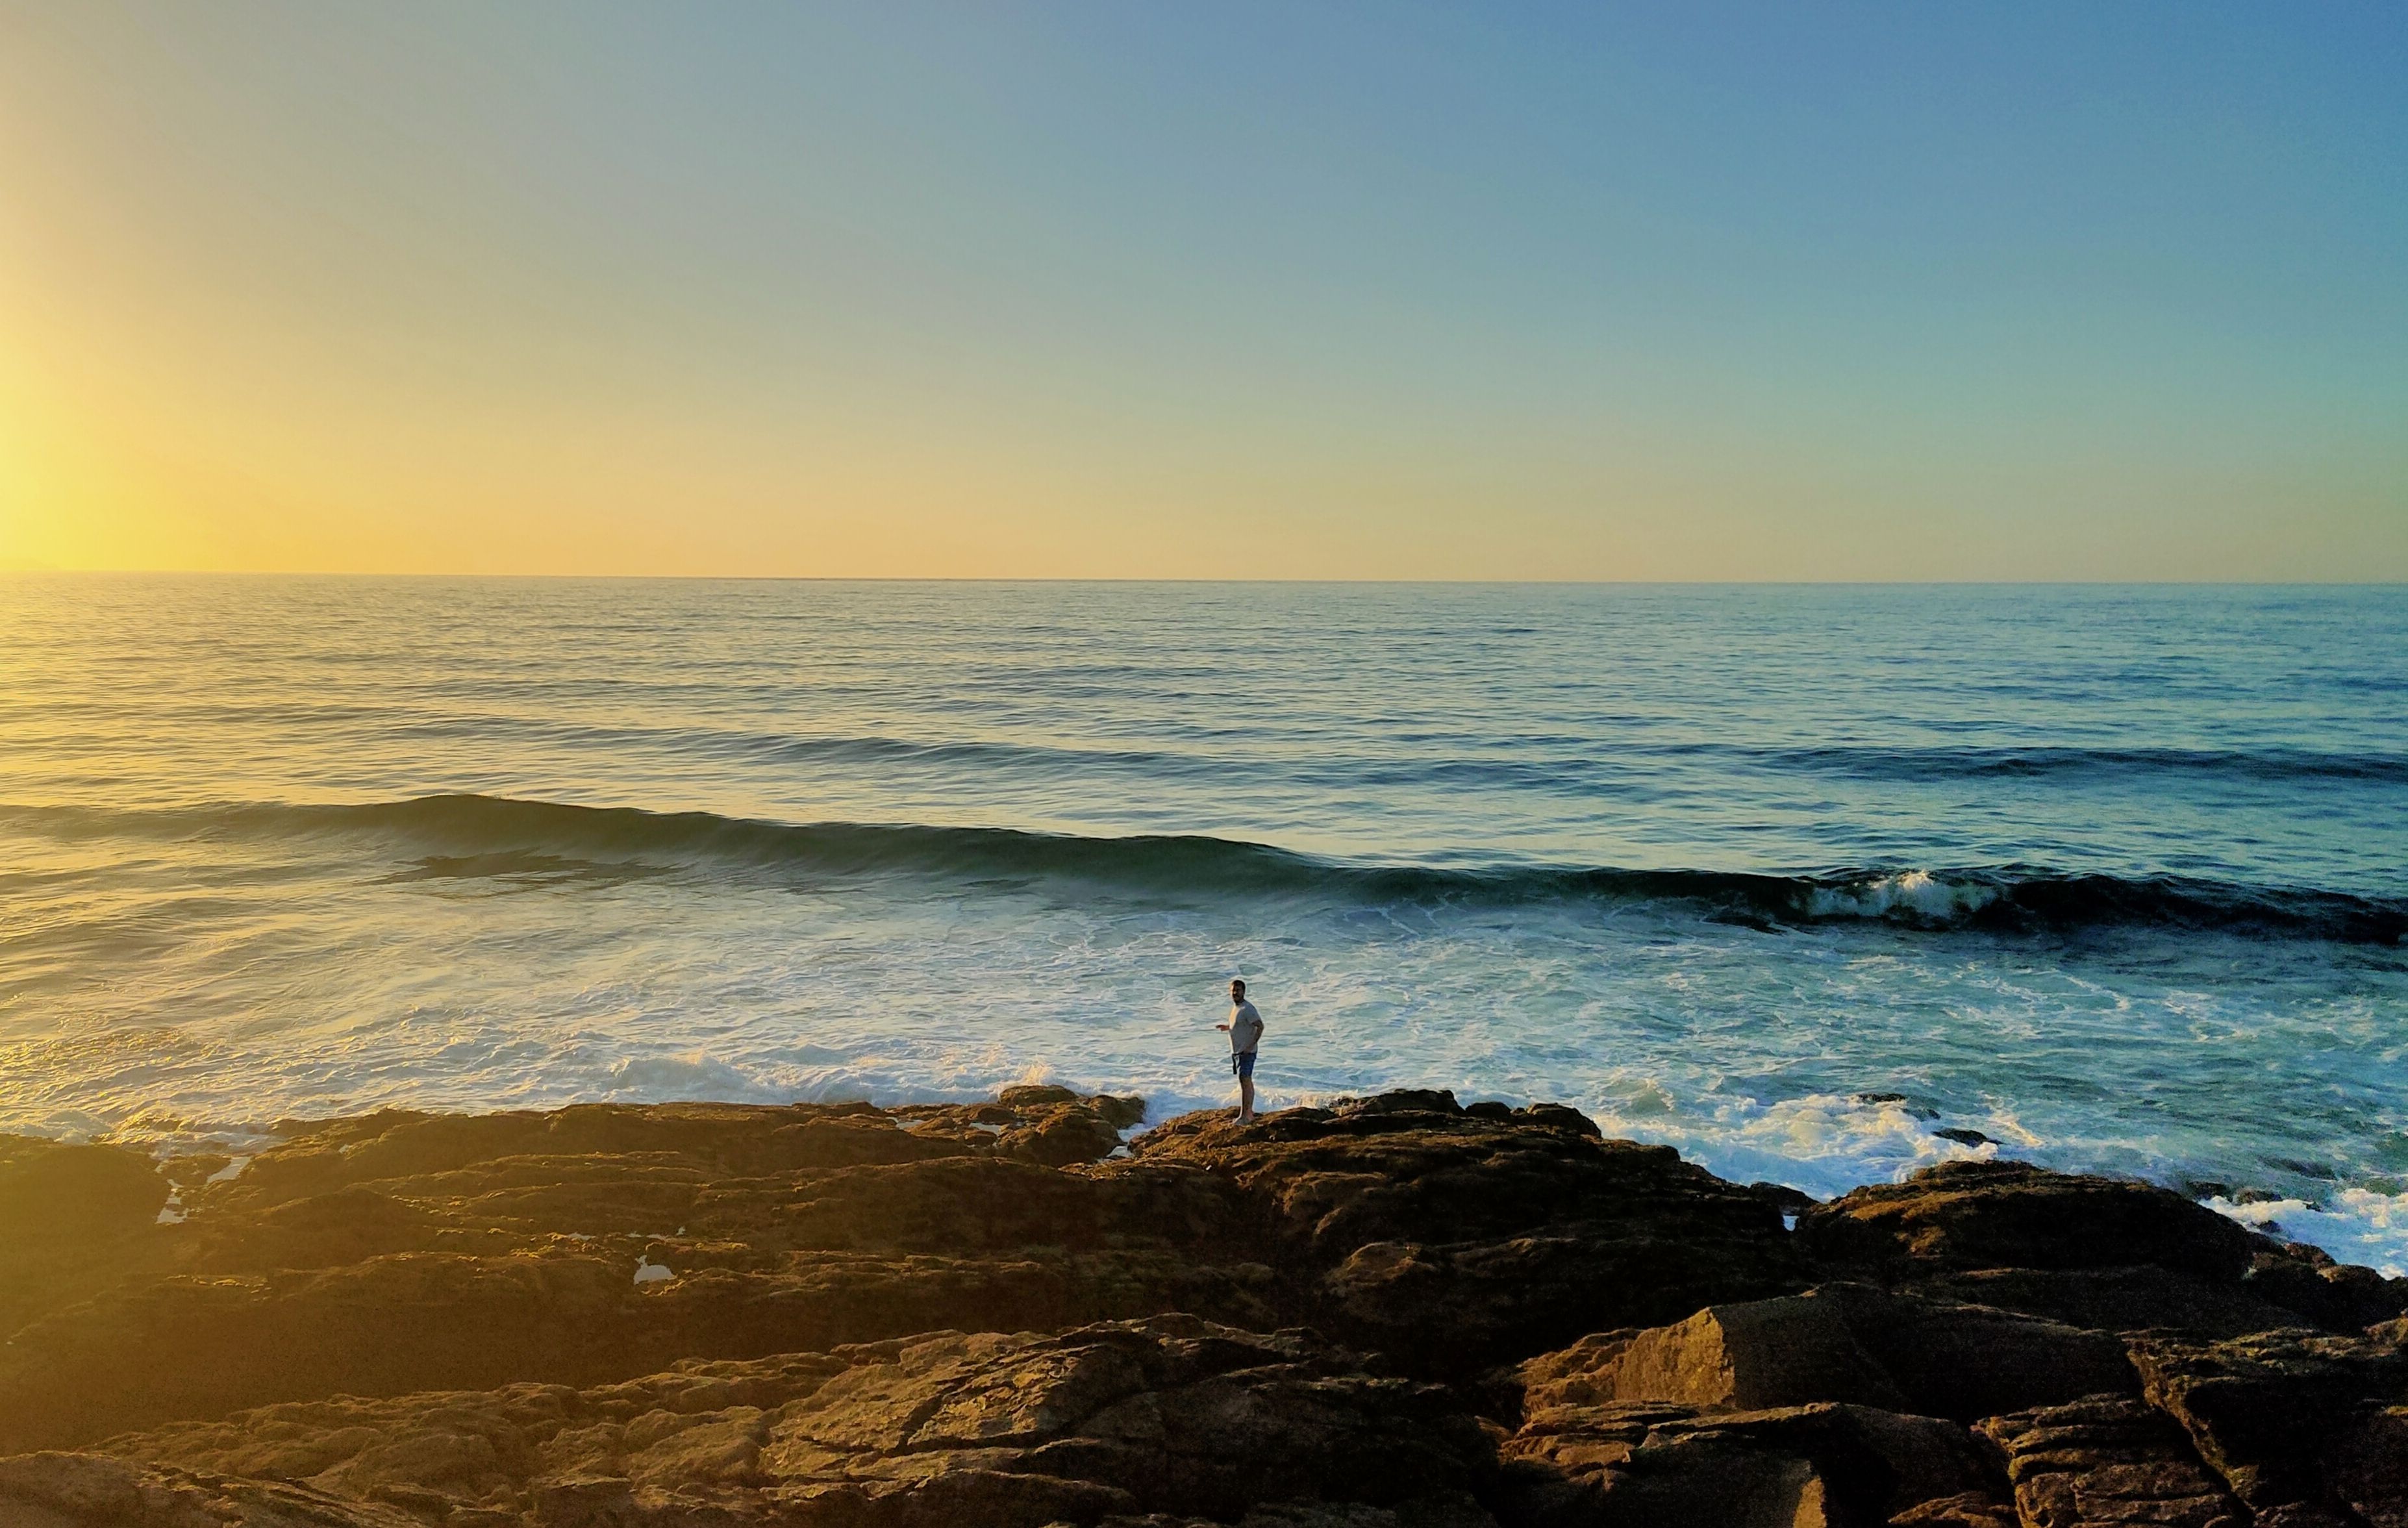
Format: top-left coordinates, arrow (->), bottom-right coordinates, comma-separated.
1796,1162 -> 2251,1283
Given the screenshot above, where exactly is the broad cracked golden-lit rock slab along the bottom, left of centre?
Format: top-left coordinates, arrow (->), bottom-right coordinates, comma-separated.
108,1316 -> 1496,1528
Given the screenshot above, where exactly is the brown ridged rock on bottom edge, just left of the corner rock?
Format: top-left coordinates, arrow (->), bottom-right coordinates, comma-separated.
1977,1396 -> 2249,1528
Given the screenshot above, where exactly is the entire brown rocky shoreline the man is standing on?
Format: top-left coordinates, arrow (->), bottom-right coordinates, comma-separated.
0,1088 -> 2408,1528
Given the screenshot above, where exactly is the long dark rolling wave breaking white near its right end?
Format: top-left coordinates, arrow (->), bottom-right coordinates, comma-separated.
0,794 -> 2408,944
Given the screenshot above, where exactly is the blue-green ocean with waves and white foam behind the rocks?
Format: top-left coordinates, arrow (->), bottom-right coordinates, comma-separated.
0,575 -> 2408,1273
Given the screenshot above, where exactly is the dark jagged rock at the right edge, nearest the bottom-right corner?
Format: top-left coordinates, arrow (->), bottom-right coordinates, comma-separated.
2131,1331 -> 2408,1514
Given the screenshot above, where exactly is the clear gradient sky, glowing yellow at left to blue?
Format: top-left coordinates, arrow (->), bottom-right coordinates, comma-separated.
0,0 -> 2408,580
